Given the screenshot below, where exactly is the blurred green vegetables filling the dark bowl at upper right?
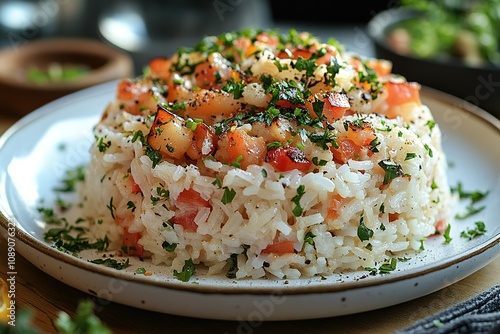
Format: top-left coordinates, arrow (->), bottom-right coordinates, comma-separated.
388,0 -> 500,66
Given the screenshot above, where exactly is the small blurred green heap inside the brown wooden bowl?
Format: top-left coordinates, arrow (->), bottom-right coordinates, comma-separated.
26,63 -> 90,84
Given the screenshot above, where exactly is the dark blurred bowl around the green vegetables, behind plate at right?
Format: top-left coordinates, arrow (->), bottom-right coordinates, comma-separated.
366,8 -> 500,118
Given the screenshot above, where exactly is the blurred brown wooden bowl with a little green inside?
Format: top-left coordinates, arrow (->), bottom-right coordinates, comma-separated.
0,38 -> 133,116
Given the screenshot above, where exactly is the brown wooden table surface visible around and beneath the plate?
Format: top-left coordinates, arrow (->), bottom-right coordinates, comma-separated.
0,114 -> 500,333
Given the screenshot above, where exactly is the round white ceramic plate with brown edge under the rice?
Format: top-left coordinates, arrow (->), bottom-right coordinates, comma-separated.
0,82 -> 500,321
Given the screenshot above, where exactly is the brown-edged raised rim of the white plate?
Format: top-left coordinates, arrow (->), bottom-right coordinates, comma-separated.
0,81 -> 500,318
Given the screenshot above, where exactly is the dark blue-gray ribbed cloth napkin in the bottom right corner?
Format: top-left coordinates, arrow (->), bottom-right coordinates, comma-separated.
394,285 -> 500,334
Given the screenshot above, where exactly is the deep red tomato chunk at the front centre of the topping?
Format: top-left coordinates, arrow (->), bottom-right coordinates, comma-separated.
266,147 -> 311,173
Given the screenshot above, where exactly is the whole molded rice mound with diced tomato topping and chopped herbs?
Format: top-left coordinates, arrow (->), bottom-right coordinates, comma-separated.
81,30 -> 450,281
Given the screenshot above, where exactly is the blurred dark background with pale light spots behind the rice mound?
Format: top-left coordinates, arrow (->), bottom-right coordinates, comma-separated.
0,0 -> 397,73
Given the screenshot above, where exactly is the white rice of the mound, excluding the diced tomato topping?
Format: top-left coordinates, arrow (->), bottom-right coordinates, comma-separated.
80,28 -> 450,279
